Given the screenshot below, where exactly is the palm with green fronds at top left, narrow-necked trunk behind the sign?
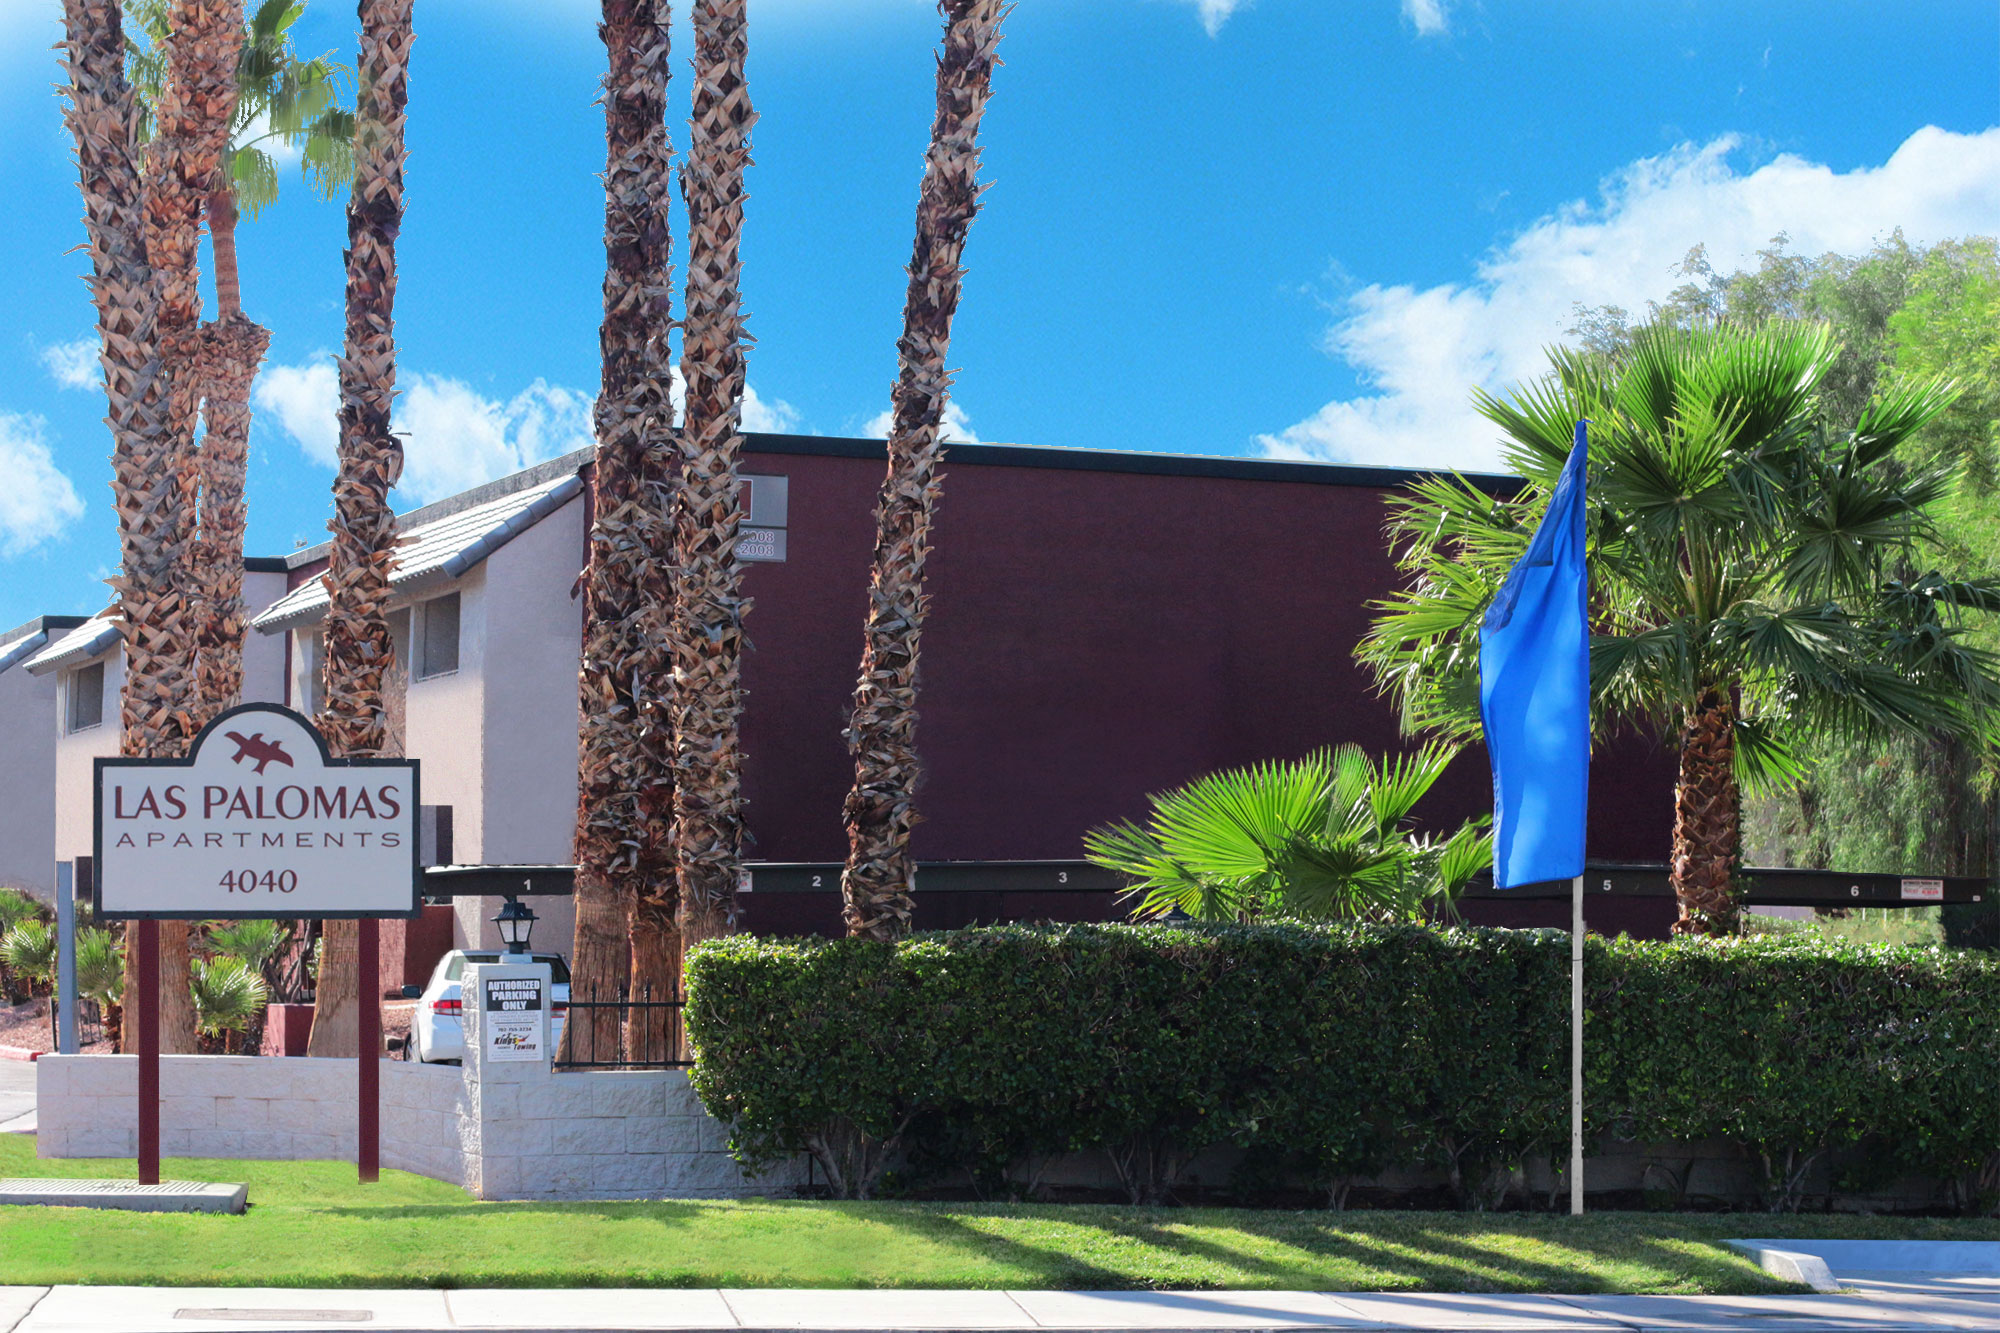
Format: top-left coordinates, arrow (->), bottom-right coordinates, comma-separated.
126,0 -> 354,729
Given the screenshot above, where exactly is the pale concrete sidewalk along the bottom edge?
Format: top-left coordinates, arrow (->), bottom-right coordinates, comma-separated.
0,1275 -> 2000,1333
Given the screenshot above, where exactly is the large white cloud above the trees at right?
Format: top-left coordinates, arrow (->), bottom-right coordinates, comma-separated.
1258,128 -> 2000,468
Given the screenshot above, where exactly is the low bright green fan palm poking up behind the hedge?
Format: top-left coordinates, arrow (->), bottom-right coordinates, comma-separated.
1084,745 -> 1492,921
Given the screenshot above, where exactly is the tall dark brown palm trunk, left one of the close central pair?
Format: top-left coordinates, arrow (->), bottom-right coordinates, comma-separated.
562,0 -> 678,1055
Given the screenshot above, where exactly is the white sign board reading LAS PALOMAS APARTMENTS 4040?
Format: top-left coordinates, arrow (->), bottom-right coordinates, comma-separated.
92,705 -> 422,919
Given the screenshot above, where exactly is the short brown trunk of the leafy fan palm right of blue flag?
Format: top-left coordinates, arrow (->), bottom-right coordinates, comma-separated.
1672,689 -> 1742,935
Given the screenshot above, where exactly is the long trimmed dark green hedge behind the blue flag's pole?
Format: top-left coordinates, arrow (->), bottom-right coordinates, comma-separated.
688,927 -> 2000,1205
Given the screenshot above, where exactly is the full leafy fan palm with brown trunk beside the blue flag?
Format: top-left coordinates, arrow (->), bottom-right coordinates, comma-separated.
1360,324 -> 2000,935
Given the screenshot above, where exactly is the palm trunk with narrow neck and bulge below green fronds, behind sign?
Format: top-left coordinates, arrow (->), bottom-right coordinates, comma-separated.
194,184 -> 270,727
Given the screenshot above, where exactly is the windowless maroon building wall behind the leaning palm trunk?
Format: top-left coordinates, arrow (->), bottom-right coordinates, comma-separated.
744,436 -> 1672,861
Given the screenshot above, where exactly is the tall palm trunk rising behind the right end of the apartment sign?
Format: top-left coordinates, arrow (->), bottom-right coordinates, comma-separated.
306,0 -> 412,1055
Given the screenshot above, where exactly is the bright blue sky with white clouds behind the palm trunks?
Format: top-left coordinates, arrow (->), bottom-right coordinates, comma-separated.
0,0 -> 2000,626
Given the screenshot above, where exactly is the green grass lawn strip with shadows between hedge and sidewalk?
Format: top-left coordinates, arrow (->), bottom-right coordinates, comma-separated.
0,1135 -> 2000,1293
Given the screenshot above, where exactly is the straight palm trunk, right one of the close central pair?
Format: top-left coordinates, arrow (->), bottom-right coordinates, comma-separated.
670,0 -> 756,949
